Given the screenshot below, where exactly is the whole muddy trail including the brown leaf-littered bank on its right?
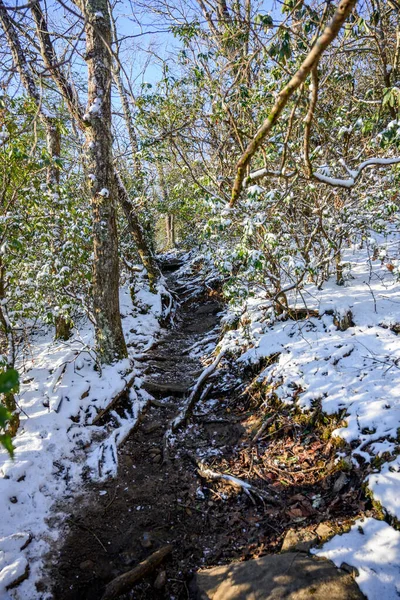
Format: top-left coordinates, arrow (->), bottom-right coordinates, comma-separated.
51,258 -> 370,600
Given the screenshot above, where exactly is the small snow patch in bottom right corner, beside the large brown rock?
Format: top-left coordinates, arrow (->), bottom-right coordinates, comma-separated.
313,518 -> 400,600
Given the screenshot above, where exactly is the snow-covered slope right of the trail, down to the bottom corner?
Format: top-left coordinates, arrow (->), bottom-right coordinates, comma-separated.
220,233 -> 400,600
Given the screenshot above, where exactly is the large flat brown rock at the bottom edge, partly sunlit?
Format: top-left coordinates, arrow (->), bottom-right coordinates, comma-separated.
192,552 -> 365,600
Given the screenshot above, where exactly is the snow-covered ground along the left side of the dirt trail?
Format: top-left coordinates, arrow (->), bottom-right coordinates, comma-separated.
0,274 -> 162,600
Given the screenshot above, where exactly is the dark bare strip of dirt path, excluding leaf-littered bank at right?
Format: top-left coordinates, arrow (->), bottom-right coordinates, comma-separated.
53,262 -> 231,600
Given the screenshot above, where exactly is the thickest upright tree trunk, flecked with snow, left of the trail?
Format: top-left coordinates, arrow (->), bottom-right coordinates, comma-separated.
80,0 -> 127,364
